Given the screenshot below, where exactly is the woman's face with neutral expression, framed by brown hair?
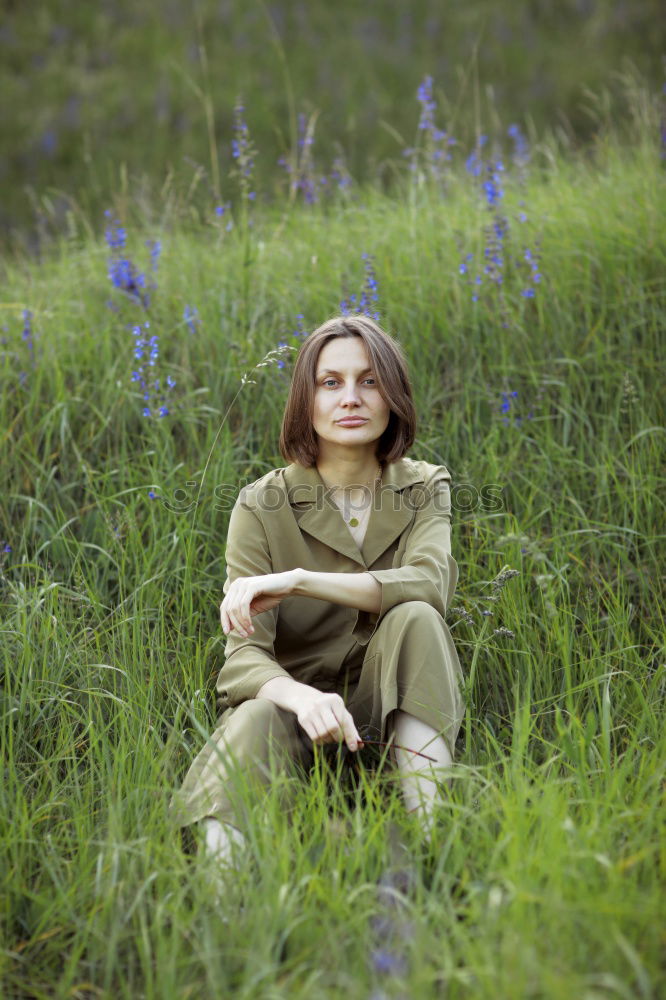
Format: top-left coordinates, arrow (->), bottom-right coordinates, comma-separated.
312,336 -> 391,458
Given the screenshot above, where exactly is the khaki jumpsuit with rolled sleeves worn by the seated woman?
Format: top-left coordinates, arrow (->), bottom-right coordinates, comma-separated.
169,458 -> 465,827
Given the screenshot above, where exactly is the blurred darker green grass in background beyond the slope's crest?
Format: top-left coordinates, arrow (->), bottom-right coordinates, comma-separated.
5,0 -> 665,248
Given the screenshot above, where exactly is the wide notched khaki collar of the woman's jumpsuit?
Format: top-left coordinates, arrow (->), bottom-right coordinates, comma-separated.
284,458 -> 425,569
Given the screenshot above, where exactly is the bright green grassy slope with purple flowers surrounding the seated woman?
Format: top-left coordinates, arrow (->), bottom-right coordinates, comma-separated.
0,76 -> 666,1000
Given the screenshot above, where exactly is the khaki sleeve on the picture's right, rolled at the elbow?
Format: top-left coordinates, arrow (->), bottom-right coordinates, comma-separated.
352,466 -> 458,646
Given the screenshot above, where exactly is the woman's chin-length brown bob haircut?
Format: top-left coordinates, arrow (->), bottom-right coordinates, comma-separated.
279,315 -> 416,468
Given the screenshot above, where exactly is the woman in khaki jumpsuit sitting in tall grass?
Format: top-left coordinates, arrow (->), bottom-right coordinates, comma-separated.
170,315 -> 464,860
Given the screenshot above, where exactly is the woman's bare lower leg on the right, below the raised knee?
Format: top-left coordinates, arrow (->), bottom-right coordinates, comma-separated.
392,711 -> 453,836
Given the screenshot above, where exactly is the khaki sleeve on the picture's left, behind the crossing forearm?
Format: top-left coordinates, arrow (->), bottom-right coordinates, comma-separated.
216,495 -> 291,707
